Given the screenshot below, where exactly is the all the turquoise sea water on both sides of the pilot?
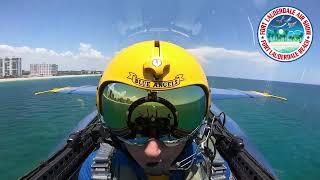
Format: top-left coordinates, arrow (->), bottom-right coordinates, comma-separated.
0,77 -> 320,179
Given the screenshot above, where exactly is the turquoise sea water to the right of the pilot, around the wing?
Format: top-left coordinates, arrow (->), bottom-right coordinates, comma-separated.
210,78 -> 320,179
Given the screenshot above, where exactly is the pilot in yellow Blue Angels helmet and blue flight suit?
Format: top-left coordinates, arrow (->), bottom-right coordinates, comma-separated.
79,41 -> 210,179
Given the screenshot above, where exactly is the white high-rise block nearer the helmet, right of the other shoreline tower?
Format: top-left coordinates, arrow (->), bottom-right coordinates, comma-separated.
30,64 -> 58,76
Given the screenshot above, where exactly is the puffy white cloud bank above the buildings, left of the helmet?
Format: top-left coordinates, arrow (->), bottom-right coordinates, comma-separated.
0,43 -> 108,70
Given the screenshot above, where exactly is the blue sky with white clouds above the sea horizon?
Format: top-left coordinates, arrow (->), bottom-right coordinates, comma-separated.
0,0 -> 320,84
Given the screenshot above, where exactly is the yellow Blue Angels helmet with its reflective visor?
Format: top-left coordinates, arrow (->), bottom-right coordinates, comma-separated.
97,41 -> 210,139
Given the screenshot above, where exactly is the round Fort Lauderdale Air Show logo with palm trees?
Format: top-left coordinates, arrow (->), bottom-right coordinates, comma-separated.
258,7 -> 312,62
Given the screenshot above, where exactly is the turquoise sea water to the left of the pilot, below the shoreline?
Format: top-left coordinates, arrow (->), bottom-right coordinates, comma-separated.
0,77 -> 98,180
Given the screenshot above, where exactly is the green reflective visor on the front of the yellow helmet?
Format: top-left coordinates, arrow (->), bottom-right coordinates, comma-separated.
101,83 -> 206,136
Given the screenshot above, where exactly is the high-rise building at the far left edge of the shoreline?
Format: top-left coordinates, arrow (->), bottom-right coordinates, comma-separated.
0,57 -> 22,78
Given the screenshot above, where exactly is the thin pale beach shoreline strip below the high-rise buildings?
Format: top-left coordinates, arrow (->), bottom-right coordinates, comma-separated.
0,74 -> 101,83
